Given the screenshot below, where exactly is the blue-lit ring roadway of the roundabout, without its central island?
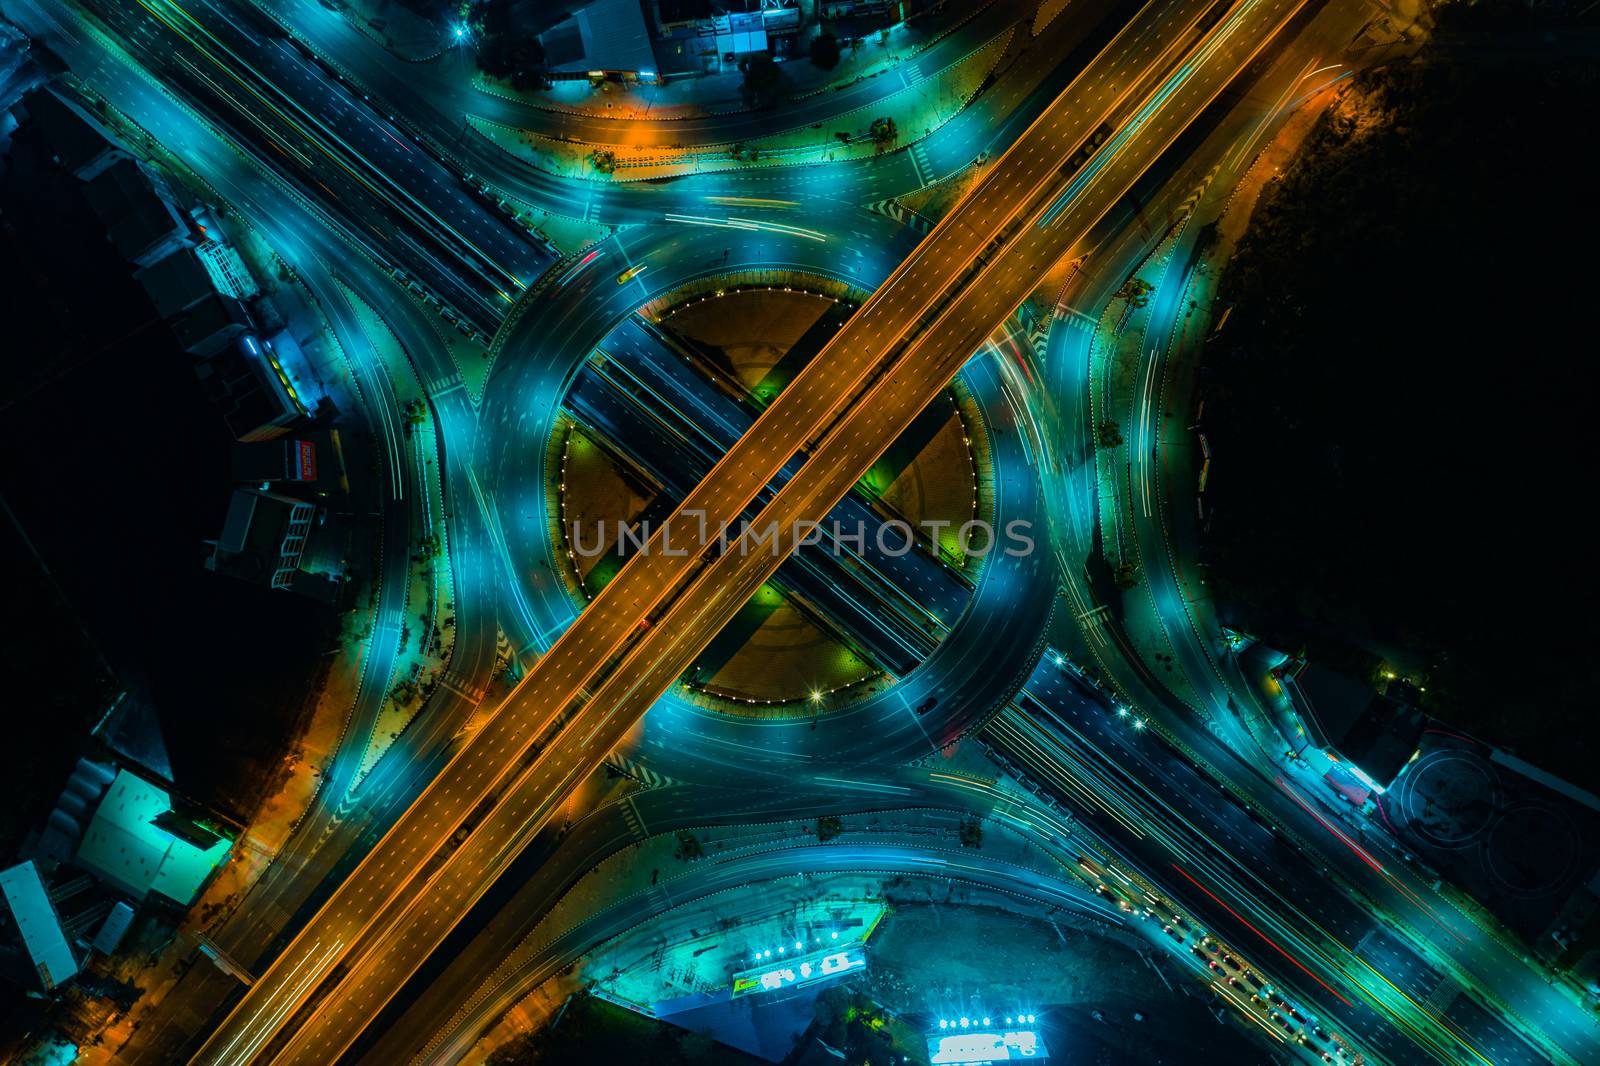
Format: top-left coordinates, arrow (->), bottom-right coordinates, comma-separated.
482,214 -> 1053,771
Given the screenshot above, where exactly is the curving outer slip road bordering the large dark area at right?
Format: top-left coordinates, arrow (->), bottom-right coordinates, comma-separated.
998,8 -> 1600,1061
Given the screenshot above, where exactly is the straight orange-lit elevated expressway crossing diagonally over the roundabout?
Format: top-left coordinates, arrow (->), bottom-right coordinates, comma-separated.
197,0 -> 1301,1063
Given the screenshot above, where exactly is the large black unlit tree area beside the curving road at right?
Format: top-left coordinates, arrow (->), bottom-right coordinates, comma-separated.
1205,40 -> 1600,781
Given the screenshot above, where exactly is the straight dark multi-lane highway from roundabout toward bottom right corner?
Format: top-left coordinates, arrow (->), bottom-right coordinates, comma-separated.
984,659 -> 1546,1063
